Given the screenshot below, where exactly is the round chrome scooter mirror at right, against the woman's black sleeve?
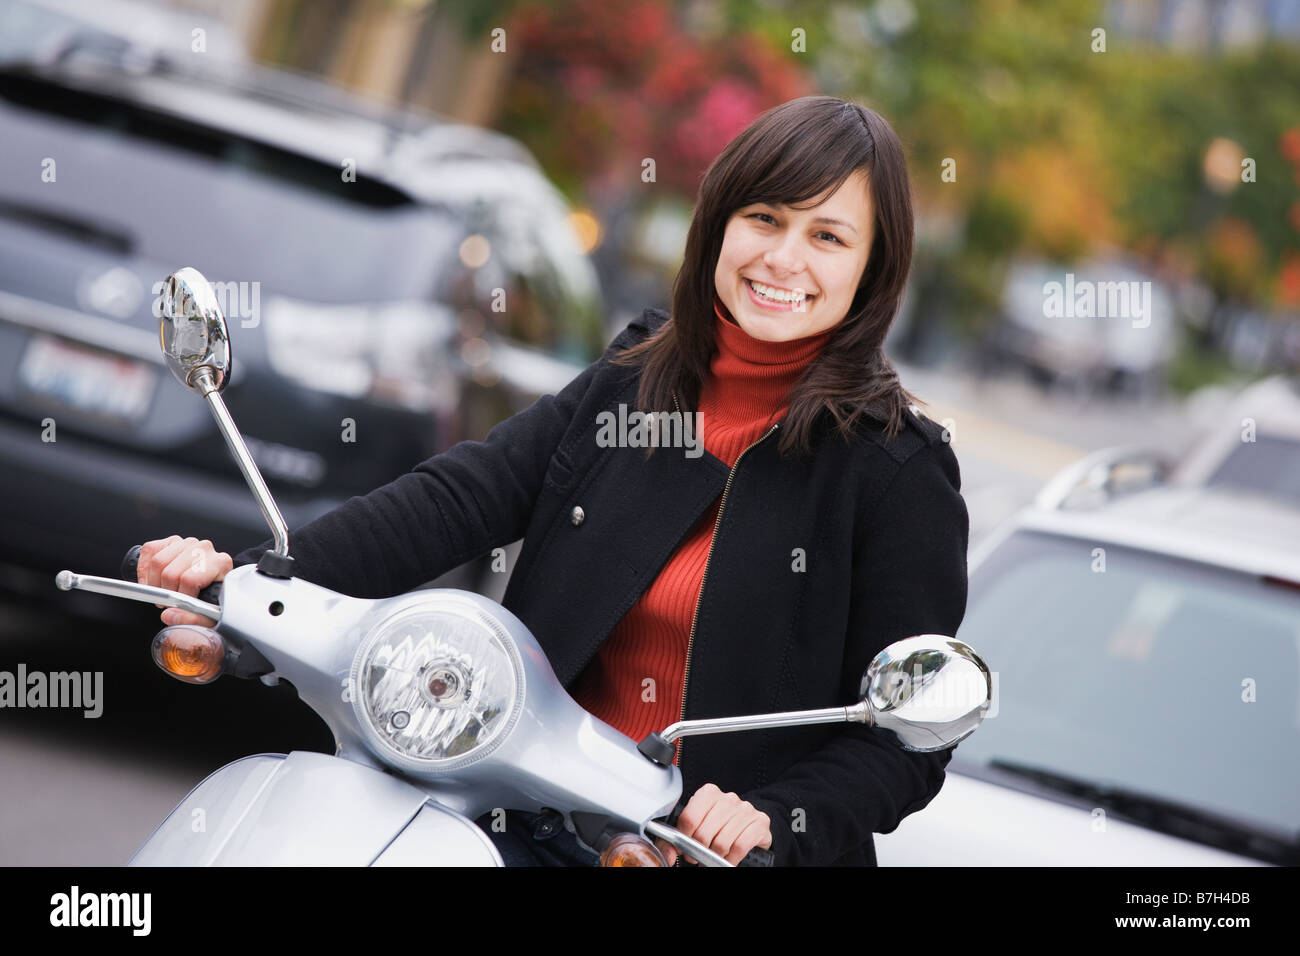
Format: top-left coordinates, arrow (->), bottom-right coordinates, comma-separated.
861,633 -> 993,752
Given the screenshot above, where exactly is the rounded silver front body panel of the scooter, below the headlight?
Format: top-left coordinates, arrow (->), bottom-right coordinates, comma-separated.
127,750 -> 503,866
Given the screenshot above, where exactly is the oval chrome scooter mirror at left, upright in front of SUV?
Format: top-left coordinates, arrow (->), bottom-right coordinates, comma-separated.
160,267 -> 230,395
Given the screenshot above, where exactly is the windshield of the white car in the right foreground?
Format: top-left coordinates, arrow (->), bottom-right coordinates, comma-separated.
954,531 -> 1300,834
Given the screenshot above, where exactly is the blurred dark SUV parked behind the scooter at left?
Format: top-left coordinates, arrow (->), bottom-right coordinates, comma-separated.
0,35 -> 608,605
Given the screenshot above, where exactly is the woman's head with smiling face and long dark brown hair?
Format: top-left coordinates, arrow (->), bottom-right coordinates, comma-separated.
615,96 -> 923,454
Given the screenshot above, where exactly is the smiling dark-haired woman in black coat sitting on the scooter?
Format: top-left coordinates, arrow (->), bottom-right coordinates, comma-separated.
140,96 -> 969,865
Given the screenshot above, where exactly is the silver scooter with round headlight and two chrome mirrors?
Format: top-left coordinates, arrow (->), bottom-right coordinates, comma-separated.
48,268 -> 992,866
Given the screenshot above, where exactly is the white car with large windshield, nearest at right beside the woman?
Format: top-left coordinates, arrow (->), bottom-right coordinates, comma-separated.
876,449 -> 1300,866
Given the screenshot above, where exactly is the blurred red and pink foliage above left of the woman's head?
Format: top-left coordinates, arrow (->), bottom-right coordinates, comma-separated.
498,0 -> 813,200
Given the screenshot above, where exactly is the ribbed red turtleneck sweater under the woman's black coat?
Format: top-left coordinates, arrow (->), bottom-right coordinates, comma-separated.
572,297 -> 831,762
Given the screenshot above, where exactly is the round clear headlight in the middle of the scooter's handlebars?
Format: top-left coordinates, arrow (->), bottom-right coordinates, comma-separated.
350,594 -> 524,774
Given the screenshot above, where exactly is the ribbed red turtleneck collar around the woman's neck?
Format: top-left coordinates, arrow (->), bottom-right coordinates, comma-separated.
701,295 -> 833,423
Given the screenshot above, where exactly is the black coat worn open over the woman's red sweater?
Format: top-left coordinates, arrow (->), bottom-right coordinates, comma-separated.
235,310 -> 969,865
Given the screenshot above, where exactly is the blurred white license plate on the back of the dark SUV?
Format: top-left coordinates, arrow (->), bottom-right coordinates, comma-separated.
18,336 -> 157,421
